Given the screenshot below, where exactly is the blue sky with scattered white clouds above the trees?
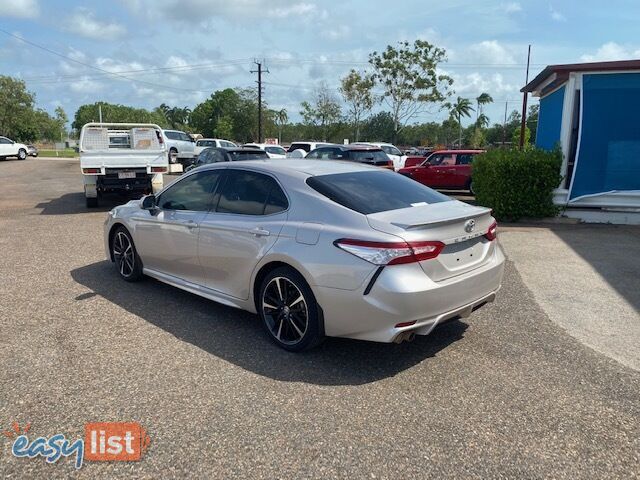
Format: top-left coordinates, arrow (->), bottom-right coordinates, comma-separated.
0,0 -> 640,129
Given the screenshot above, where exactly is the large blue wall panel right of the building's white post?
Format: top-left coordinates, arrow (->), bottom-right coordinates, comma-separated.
572,73 -> 640,199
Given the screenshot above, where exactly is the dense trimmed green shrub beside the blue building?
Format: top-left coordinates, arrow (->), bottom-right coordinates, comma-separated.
473,148 -> 562,221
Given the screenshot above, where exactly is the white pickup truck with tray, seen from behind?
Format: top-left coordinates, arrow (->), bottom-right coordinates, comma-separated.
79,123 -> 169,208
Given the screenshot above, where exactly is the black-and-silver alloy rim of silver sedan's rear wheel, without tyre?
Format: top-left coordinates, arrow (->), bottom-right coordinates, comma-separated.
262,277 -> 309,345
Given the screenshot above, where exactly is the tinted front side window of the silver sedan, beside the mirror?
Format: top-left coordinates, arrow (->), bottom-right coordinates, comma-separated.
158,171 -> 221,212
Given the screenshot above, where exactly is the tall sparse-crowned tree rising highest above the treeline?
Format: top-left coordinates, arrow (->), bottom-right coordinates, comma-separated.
369,40 -> 453,140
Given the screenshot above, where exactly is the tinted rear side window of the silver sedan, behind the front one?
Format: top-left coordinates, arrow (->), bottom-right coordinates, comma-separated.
216,170 -> 287,215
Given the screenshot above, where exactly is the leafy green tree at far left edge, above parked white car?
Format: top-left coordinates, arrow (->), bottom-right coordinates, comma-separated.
0,75 -> 35,140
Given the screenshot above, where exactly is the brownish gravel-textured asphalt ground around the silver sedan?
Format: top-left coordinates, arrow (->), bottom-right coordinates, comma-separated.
0,159 -> 640,479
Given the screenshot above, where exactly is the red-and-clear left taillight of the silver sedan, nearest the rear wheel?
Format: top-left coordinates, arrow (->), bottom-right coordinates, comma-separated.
334,238 -> 444,265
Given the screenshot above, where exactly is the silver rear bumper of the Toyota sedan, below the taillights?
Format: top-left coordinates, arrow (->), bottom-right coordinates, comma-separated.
314,244 -> 504,342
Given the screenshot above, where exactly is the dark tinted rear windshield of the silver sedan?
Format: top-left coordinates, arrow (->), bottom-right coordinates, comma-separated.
307,170 -> 452,215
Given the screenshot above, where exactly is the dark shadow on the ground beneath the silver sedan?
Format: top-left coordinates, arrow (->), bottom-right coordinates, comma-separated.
71,261 -> 467,385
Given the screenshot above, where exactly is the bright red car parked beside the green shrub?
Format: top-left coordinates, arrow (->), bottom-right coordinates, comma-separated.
398,150 -> 485,193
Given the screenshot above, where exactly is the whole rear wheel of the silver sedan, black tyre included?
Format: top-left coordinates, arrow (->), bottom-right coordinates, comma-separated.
256,267 -> 324,352
